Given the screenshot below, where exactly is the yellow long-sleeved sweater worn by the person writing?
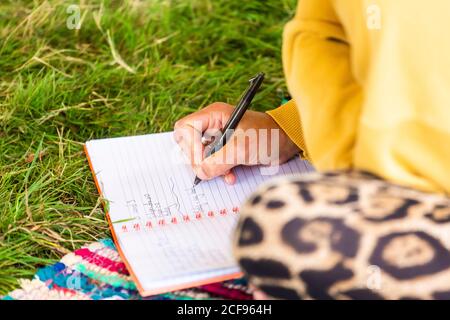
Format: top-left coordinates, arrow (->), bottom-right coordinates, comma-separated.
269,0 -> 450,193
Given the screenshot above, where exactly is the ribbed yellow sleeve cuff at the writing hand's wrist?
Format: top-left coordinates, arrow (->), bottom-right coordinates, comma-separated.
267,100 -> 309,160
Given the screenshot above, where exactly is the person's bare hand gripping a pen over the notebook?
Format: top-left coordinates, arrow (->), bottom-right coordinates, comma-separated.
174,102 -> 299,184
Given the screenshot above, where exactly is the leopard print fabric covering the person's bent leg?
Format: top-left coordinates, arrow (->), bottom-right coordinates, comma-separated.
234,172 -> 450,299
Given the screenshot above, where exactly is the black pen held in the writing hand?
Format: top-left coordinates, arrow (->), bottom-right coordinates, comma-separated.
193,72 -> 264,187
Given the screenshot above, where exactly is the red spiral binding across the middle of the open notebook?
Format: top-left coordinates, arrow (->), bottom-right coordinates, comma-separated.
120,207 -> 239,233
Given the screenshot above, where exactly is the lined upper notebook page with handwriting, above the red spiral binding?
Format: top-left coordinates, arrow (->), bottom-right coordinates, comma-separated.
90,134 -> 310,224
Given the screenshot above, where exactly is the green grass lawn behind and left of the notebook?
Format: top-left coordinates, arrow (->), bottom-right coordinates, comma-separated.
0,0 -> 296,294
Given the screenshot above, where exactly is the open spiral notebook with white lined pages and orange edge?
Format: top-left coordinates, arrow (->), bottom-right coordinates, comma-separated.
85,132 -> 312,296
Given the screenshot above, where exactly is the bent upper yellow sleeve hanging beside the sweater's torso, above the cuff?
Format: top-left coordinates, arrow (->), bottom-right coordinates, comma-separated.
283,0 -> 362,170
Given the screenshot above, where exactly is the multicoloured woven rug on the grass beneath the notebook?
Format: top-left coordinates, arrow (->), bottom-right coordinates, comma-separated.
3,239 -> 252,300
